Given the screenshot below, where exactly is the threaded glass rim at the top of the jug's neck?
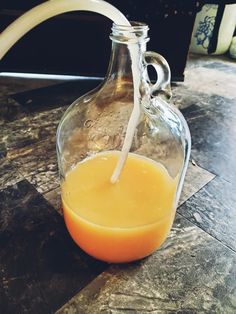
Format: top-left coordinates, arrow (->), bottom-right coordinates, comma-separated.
110,21 -> 149,43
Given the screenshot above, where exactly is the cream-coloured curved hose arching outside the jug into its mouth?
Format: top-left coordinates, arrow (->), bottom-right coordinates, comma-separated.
0,0 -> 130,60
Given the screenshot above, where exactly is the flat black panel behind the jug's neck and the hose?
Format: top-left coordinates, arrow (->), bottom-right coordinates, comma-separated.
0,0 -> 201,80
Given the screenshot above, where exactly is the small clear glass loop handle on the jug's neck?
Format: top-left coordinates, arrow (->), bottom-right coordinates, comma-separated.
143,51 -> 172,100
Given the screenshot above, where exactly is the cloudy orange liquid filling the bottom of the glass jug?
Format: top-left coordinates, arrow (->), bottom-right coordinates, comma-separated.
62,151 -> 177,262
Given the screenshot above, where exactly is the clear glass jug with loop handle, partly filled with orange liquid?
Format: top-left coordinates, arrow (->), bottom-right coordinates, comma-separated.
57,23 -> 190,262
